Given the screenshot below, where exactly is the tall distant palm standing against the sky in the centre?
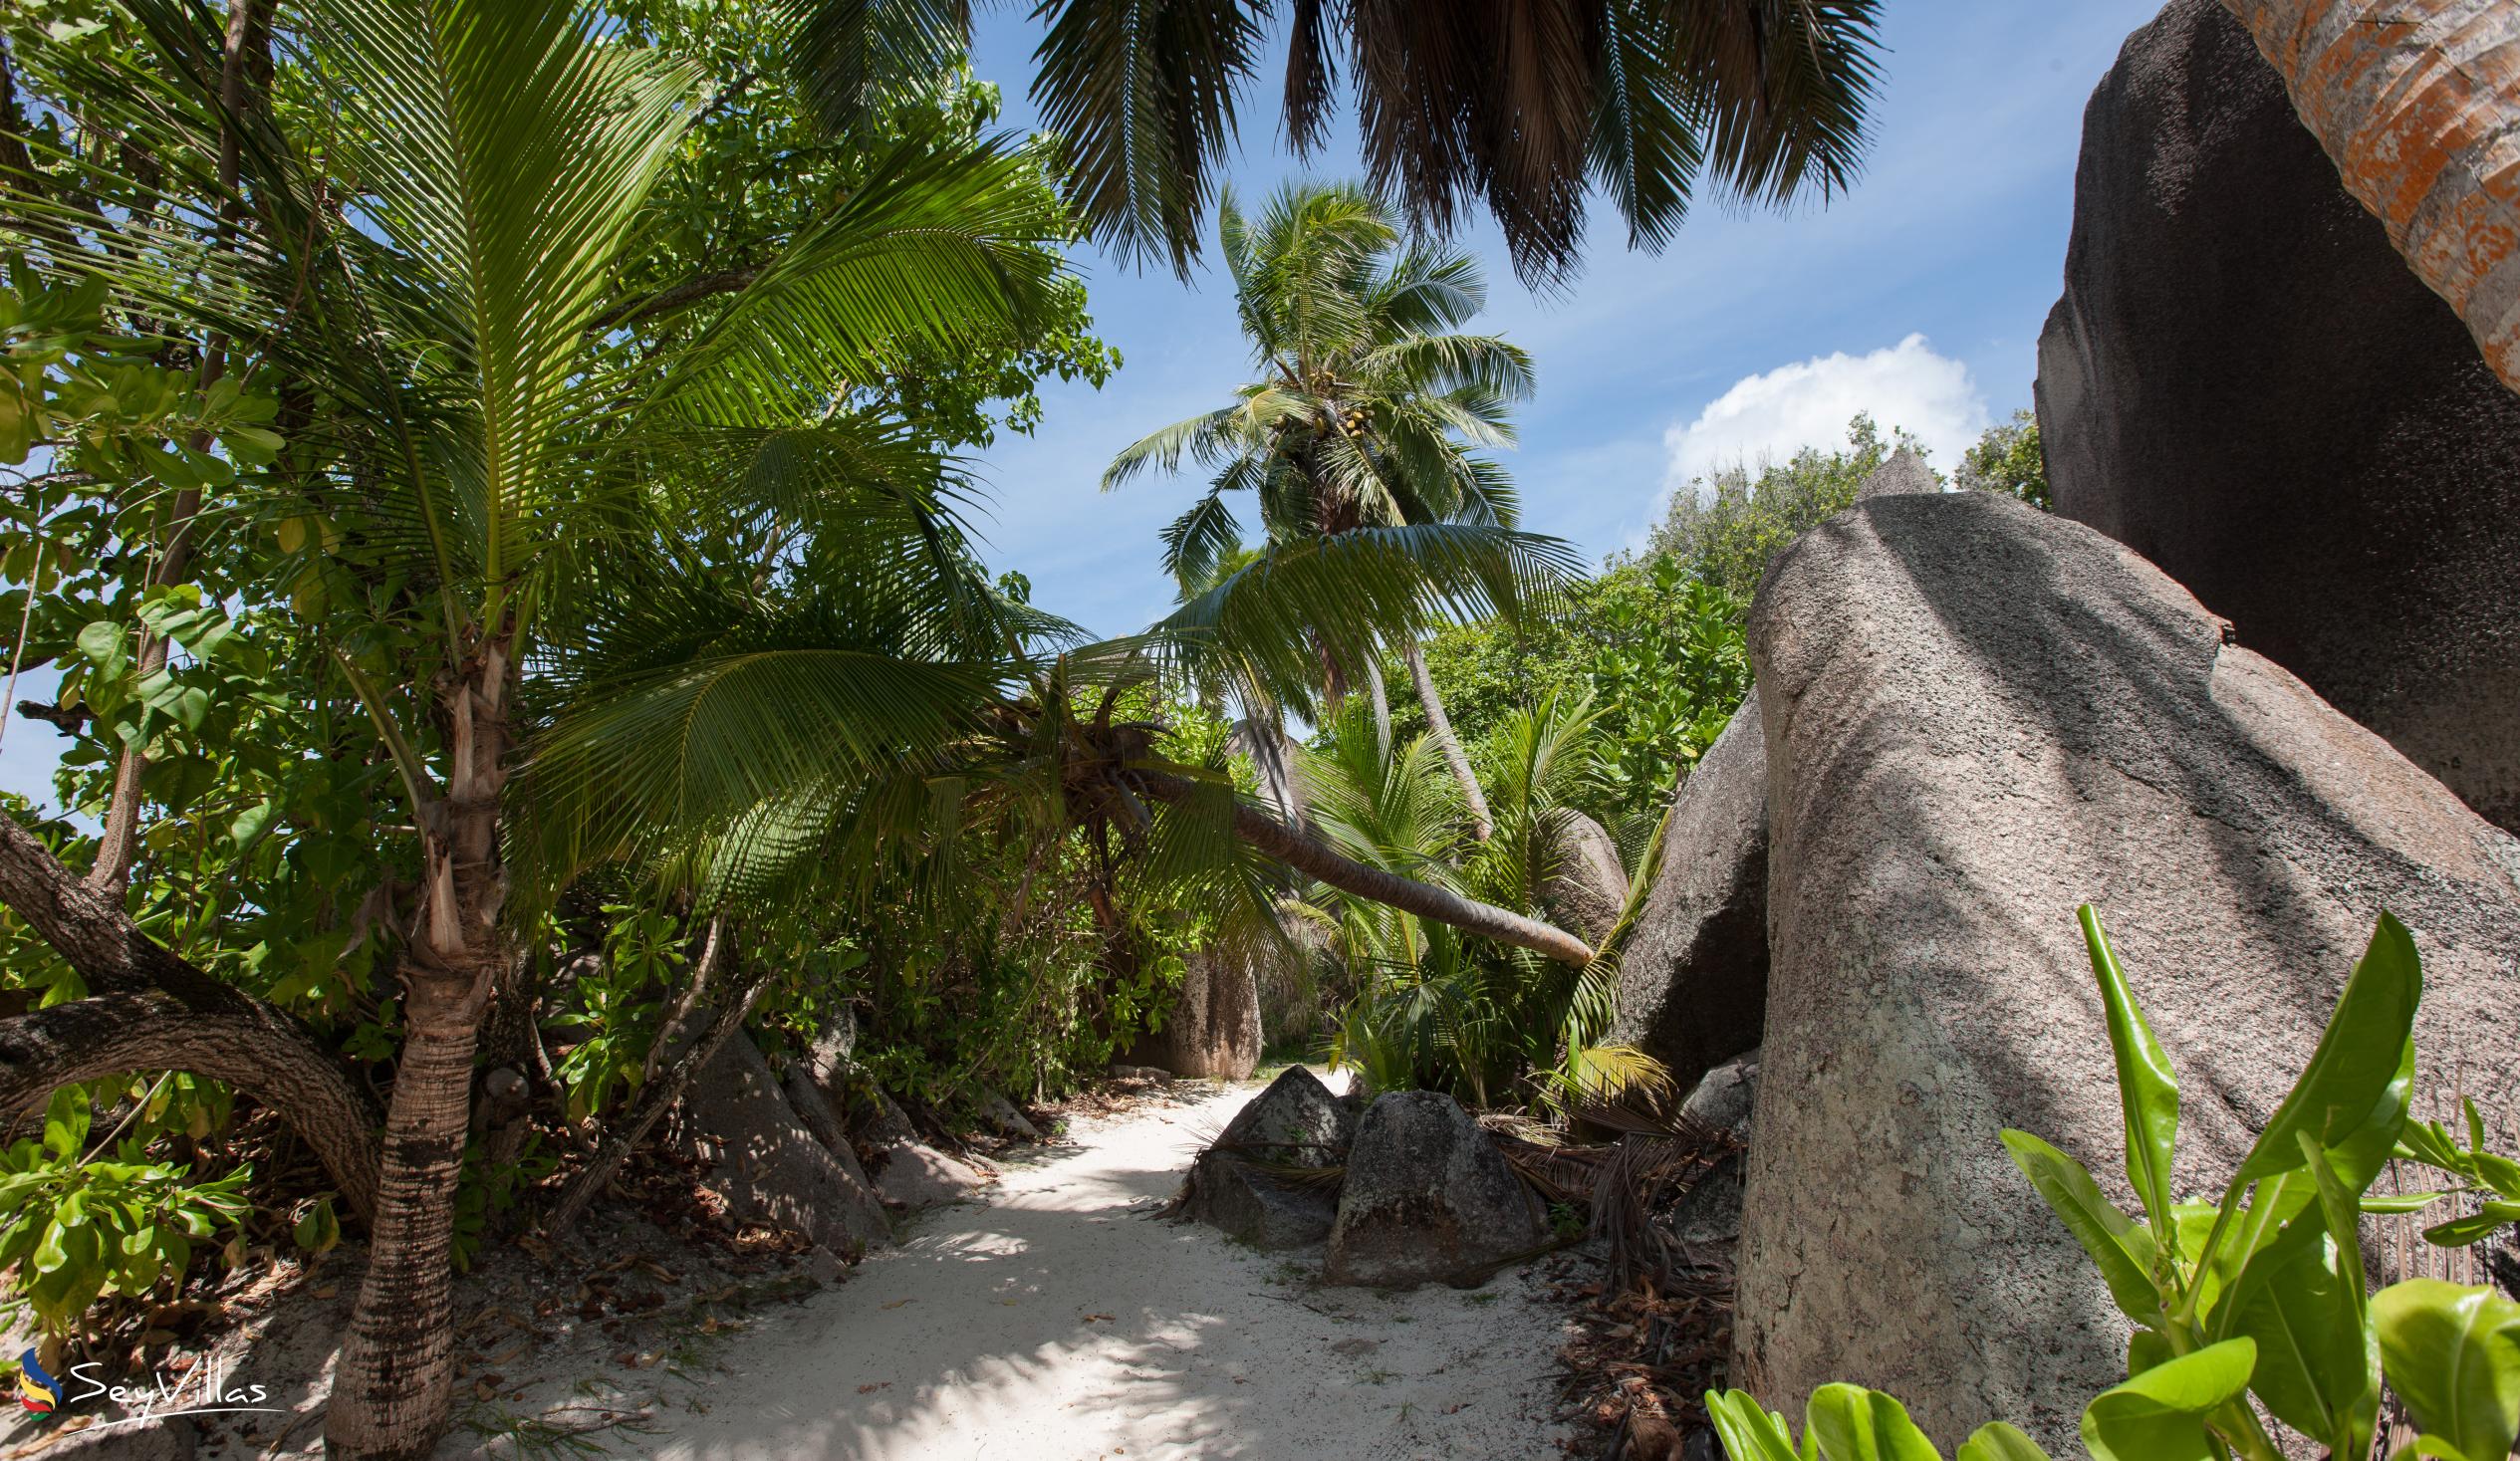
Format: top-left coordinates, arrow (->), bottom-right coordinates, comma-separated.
1104,186 -> 1532,839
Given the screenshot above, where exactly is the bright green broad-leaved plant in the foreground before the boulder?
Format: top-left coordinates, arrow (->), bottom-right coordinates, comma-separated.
1706,907 -> 2520,1461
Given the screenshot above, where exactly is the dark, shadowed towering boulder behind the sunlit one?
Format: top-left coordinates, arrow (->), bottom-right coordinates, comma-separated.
2039,0 -> 2520,829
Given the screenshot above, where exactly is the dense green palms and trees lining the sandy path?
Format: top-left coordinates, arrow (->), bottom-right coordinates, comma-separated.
0,0 -> 2510,1456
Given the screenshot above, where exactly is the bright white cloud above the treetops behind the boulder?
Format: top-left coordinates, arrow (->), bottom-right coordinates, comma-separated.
1663,335 -> 1988,499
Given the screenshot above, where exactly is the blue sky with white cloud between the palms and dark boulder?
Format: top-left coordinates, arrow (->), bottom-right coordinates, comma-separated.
0,0 -> 2157,806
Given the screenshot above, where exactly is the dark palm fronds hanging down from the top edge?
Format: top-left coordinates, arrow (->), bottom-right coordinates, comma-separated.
1013,0 -> 1880,280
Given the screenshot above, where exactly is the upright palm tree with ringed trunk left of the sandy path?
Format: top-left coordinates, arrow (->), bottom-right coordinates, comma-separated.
0,0 -> 1064,1456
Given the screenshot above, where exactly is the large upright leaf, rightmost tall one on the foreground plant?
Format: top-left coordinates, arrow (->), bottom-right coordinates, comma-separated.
2235,912 -> 2424,1194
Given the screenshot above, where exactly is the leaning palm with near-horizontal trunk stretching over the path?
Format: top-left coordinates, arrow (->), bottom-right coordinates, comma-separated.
524,522 -> 1593,965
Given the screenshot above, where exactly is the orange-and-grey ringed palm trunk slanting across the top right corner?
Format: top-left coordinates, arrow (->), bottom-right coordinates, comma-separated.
2222,0 -> 2520,390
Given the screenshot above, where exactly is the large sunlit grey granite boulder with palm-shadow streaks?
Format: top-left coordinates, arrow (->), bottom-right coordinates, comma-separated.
1734,491 -> 2520,1453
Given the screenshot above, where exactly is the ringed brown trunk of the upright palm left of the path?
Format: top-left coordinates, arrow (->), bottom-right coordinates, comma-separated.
325,641 -> 514,1461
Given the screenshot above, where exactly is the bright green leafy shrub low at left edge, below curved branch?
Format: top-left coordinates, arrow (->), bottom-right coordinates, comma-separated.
0,1086 -> 252,1336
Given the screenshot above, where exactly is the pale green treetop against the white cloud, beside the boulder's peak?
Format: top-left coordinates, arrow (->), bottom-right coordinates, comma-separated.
1653,413 -> 1922,603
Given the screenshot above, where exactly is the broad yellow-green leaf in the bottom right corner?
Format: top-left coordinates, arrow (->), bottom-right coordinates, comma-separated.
2372,1280 -> 2520,1456
